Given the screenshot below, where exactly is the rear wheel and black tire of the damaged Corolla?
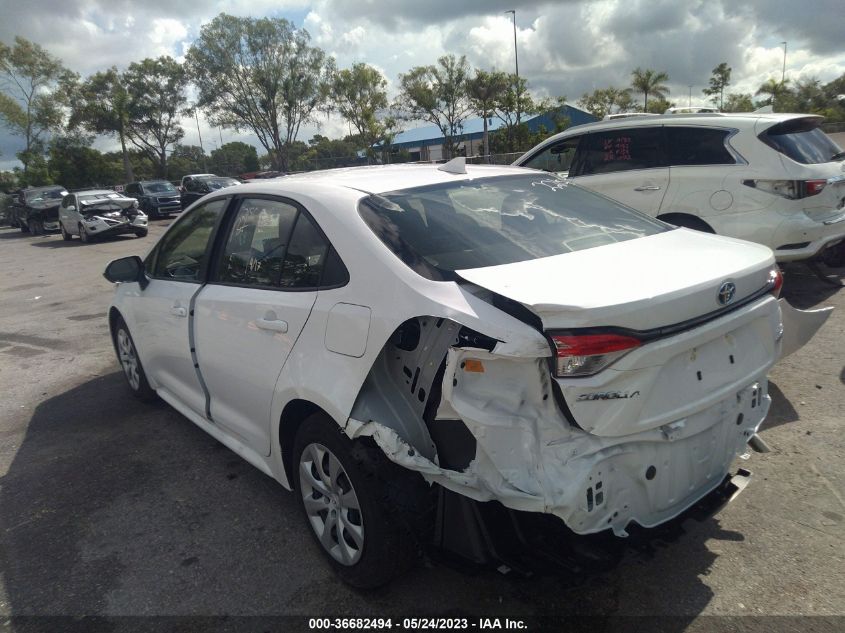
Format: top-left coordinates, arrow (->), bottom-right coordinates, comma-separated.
293,413 -> 422,589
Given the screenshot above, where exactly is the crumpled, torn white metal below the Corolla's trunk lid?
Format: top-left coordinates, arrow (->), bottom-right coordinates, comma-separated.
346,348 -> 770,536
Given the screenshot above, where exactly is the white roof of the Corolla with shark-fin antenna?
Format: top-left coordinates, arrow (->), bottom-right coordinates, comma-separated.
234,163 -> 537,193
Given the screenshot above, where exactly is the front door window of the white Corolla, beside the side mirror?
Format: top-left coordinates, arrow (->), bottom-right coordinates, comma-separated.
152,198 -> 229,283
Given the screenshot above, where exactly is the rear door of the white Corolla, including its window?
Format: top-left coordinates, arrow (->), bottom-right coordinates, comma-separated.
194,196 -> 344,455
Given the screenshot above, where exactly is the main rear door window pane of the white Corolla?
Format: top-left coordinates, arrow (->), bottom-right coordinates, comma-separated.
218,198 -> 299,286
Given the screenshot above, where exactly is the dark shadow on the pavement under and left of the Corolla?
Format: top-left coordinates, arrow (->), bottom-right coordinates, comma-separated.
0,372 -> 744,631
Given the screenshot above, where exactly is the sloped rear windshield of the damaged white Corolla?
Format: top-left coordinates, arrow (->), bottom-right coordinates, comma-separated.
359,174 -> 669,280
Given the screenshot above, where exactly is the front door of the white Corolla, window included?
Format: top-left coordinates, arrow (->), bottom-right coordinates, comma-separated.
129,198 -> 229,416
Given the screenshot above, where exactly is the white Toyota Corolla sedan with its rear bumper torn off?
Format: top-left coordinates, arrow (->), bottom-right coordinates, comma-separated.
105,159 -> 796,587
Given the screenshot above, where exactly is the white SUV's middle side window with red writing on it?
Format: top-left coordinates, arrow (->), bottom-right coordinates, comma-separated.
569,127 -> 665,176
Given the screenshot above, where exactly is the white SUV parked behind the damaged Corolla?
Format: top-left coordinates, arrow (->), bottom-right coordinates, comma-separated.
514,113 -> 845,262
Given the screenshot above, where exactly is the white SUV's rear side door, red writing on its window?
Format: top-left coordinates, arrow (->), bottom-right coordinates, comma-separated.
569,126 -> 669,216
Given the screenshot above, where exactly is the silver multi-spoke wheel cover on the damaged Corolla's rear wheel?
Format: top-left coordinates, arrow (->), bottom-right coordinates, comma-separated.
299,443 -> 364,566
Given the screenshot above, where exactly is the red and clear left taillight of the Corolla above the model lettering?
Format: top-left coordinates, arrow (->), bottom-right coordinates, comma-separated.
551,334 -> 642,378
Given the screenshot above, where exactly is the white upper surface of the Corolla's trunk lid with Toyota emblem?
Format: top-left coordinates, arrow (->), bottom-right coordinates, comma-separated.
457,229 -> 774,330
